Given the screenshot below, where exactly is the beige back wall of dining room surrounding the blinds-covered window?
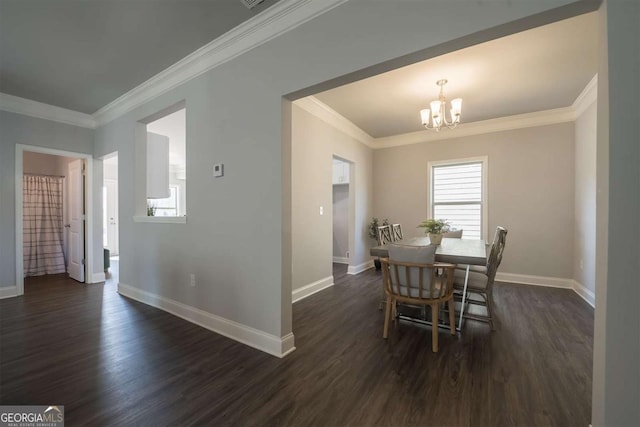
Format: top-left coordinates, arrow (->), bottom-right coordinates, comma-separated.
373,123 -> 574,278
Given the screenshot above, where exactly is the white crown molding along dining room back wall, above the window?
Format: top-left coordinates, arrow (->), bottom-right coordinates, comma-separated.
373,107 -> 576,149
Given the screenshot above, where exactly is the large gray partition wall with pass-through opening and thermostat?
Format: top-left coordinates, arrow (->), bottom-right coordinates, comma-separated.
89,0 -> 584,342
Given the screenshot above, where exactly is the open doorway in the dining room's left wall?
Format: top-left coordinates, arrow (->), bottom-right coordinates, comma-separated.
332,156 -> 351,265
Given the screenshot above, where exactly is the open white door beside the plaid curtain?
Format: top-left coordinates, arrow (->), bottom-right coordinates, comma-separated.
68,159 -> 84,282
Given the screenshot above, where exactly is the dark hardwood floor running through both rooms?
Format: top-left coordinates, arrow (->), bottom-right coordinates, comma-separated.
0,265 -> 593,427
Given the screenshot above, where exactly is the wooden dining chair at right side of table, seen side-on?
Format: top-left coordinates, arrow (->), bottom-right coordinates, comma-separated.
454,227 -> 507,331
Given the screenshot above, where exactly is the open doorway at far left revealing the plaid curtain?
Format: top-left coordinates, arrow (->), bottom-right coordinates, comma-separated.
16,146 -> 92,295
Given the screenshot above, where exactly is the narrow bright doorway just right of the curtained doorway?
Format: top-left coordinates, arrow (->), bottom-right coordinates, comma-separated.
102,152 -> 120,278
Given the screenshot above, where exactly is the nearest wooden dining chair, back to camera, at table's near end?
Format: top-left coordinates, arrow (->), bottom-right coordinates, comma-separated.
381,244 -> 456,353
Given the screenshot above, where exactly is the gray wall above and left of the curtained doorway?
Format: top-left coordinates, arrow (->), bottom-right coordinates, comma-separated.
0,111 -> 94,287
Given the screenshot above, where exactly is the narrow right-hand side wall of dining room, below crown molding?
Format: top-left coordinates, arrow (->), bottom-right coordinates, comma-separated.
573,102 -> 598,293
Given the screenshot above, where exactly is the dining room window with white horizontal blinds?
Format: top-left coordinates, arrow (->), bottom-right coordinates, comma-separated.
429,158 -> 487,239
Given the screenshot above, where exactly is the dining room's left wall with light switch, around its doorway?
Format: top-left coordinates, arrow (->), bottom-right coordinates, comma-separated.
292,103 -> 373,289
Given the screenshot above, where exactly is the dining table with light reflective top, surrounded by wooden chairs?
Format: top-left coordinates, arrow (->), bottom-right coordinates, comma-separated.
369,236 -> 487,331
